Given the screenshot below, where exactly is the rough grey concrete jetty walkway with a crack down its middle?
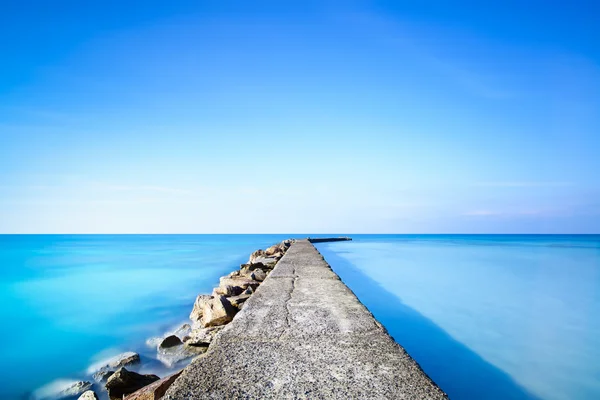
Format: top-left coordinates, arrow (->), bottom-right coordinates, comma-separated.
165,240 -> 447,400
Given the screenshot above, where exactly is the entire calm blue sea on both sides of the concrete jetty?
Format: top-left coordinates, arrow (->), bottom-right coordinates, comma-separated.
0,235 -> 600,400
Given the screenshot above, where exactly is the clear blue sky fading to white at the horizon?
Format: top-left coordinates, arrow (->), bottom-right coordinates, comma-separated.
0,1 -> 600,233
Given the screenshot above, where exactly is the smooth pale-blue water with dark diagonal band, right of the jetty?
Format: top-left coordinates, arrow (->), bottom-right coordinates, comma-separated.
317,235 -> 600,400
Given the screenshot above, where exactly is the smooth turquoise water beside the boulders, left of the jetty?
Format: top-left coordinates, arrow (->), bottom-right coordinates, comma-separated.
0,235 -> 298,400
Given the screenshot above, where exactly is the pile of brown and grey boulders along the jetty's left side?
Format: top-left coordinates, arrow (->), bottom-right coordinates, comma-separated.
31,240 -> 294,400
